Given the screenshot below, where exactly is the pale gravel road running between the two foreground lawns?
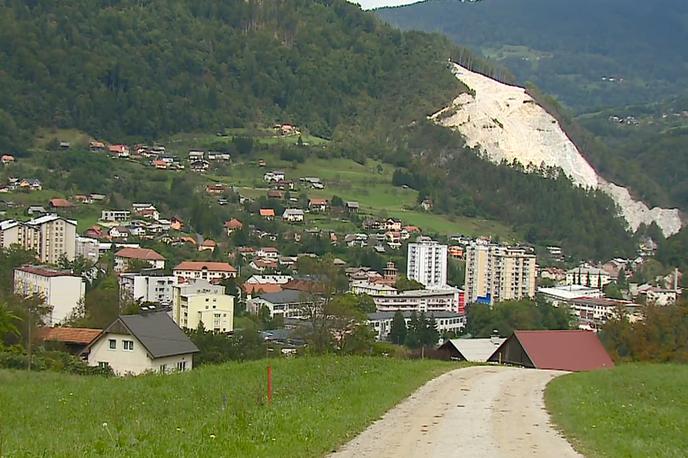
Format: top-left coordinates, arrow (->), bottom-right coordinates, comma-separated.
330,366 -> 581,458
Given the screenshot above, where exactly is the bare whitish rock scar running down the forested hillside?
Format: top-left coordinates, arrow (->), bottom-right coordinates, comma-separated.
432,64 -> 681,236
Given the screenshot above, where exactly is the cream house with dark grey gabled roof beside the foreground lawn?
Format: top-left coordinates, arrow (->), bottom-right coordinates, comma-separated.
84,312 -> 199,376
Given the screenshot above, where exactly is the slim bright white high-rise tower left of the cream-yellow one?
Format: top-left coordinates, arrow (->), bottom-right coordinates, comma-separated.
406,237 -> 447,288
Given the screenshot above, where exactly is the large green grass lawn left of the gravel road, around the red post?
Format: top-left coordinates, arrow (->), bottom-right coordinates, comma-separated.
0,357 -> 456,457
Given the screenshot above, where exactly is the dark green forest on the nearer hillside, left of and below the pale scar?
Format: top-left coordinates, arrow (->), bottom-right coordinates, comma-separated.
0,0 -> 634,258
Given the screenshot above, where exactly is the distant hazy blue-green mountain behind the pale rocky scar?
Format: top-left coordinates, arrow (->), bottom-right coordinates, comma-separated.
378,0 -> 688,112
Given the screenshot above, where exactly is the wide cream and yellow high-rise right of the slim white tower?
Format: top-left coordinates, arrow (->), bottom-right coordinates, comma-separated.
465,242 -> 537,304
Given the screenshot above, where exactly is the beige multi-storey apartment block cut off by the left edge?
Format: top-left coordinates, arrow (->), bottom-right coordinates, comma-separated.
0,215 -> 76,264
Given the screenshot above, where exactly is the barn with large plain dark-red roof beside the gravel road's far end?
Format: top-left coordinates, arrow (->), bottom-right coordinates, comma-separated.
488,331 -> 614,372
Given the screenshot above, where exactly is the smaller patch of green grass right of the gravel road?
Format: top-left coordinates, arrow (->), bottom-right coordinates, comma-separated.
545,364 -> 688,458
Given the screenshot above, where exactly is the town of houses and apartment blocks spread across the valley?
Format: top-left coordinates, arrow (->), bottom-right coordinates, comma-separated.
0,154 -> 682,375
